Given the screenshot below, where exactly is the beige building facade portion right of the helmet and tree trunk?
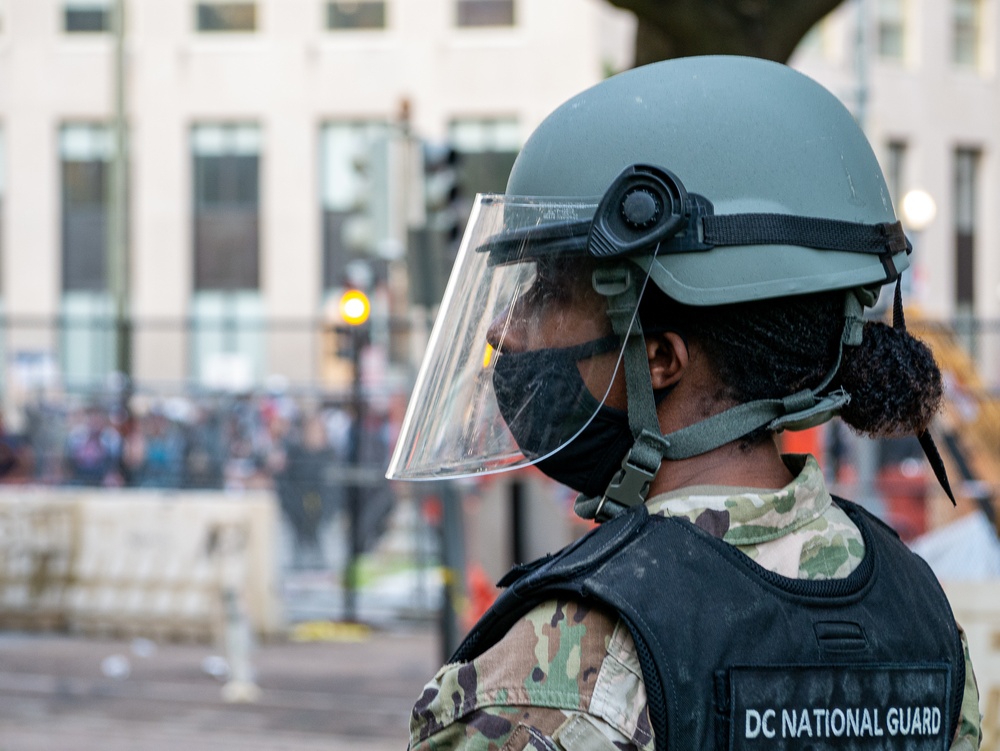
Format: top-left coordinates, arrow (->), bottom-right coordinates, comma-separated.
792,0 -> 1000,334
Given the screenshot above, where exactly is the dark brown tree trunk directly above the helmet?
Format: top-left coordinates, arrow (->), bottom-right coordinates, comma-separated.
608,0 -> 842,65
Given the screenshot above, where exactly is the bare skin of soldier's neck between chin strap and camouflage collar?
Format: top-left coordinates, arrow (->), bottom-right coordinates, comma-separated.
647,440 -> 794,498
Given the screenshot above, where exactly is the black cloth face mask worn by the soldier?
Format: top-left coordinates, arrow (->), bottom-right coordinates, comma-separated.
493,334 -> 667,497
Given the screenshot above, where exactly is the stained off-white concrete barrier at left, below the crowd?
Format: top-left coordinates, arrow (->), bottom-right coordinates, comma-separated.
0,487 -> 285,640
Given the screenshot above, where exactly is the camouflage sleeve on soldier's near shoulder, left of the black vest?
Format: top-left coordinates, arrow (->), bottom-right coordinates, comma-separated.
410,601 -> 648,751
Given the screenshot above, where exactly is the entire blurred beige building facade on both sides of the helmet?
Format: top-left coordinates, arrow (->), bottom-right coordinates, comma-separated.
0,0 -> 1000,402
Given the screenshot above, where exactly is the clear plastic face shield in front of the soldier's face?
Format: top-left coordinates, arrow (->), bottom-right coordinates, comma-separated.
387,195 -> 645,480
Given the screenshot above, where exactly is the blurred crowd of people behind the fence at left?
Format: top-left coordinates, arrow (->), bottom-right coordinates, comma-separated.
0,391 -> 392,560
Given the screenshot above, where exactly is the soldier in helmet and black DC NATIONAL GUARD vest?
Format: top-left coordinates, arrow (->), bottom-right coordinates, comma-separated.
389,57 -> 980,751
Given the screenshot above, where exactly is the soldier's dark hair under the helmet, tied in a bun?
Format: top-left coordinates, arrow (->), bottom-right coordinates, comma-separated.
640,288 -> 942,445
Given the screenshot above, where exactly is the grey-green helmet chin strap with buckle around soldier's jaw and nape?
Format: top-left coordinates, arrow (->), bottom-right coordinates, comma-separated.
575,264 -> 954,521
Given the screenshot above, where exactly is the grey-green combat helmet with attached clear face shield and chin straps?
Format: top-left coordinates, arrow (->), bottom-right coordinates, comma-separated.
388,57 -> 950,518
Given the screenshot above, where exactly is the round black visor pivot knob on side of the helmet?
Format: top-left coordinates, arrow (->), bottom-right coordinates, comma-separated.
587,164 -> 689,258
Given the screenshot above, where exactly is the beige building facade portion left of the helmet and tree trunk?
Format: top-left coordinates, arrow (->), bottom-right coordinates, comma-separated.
0,0 -> 633,406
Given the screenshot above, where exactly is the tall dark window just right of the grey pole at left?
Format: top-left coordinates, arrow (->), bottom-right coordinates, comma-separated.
191,124 -> 260,290
